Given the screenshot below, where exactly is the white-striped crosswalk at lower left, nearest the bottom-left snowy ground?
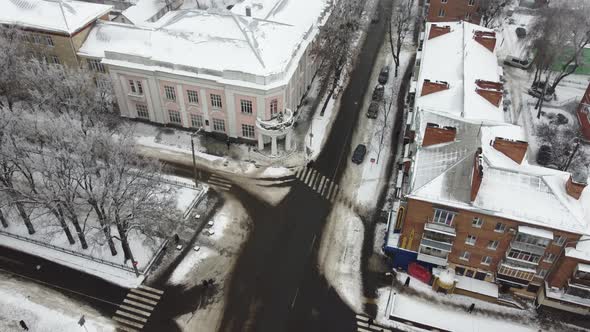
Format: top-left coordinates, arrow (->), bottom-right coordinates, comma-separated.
113,285 -> 164,332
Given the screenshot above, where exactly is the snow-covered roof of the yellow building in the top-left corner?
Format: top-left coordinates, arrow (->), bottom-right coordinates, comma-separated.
0,0 -> 112,34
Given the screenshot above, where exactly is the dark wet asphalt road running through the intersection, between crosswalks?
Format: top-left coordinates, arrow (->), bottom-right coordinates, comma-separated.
0,0 -> 392,332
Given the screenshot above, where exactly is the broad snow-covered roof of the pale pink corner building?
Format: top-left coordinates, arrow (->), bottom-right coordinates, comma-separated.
79,0 -> 329,84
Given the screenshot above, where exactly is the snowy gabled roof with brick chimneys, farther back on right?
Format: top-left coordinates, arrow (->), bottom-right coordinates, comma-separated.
416,22 -> 504,123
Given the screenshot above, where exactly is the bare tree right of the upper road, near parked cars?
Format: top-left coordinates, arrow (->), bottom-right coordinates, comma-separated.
389,0 -> 416,77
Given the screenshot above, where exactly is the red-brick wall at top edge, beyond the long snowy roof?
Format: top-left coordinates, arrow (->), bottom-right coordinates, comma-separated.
427,0 -> 481,24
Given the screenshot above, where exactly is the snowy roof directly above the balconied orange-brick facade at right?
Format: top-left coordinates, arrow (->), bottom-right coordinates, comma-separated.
409,111 -> 590,235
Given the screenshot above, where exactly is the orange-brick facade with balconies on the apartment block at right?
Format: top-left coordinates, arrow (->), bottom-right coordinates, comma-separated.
400,198 -> 580,284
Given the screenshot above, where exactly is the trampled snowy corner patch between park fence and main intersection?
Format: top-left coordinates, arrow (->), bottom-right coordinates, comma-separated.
168,197 -> 252,331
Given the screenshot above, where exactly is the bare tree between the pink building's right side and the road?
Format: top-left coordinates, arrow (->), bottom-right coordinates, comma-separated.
311,0 -> 364,113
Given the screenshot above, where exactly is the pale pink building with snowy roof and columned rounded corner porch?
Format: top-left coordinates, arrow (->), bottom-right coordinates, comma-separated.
79,0 -> 329,154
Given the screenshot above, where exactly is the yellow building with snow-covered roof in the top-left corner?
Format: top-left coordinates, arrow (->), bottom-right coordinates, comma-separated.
0,0 -> 112,66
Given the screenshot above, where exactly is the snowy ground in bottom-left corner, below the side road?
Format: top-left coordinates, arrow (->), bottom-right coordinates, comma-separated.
0,271 -> 115,332
